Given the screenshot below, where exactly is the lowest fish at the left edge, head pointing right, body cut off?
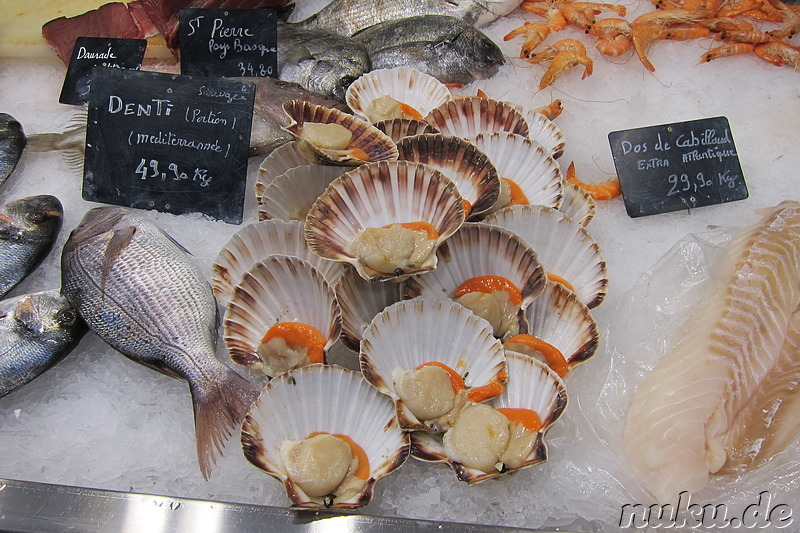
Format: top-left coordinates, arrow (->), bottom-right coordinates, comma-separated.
0,289 -> 86,398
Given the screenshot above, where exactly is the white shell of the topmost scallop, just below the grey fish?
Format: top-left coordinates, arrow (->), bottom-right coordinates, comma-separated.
345,67 -> 453,122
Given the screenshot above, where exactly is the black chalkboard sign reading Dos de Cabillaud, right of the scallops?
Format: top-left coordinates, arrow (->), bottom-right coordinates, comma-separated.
608,117 -> 748,217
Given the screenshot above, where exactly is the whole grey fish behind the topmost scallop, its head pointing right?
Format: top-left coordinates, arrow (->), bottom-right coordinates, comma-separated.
353,15 -> 505,84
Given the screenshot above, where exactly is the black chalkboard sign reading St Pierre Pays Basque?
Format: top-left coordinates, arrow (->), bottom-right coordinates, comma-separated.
179,9 -> 278,78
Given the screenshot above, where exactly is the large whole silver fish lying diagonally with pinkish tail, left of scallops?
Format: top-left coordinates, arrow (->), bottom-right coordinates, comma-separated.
61,207 -> 260,479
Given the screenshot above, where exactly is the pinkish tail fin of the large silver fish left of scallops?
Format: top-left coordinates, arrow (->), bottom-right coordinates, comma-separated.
189,367 -> 261,479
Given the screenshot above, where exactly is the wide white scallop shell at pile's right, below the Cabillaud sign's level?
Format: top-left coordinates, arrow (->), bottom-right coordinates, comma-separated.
483,205 -> 608,309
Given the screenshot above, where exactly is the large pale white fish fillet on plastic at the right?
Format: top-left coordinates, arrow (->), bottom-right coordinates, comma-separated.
625,202 -> 800,502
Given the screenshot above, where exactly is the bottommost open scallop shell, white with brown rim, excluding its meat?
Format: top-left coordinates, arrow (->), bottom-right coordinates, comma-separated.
242,365 -> 409,509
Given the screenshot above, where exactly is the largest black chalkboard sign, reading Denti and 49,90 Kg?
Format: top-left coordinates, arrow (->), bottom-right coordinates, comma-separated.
83,67 -> 255,224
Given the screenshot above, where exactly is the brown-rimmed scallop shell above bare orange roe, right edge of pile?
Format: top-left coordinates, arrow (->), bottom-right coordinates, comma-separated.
525,283 -> 600,370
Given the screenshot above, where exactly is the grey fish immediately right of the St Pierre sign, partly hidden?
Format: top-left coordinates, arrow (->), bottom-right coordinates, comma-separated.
278,24 -> 370,102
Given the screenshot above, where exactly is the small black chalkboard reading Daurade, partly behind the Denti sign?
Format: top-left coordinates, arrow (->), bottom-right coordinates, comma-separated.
58,37 -> 147,105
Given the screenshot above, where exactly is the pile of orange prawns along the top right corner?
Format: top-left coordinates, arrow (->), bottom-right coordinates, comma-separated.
504,0 -> 800,89
